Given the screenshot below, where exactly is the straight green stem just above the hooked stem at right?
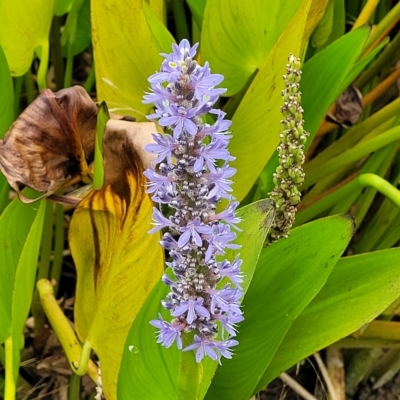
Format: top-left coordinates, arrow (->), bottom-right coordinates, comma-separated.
301,126 -> 400,190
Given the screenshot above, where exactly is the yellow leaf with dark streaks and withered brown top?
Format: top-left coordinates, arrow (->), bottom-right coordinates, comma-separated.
69,123 -> 164,399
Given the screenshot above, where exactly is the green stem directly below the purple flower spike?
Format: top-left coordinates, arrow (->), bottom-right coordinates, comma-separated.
177,335 -> 203,400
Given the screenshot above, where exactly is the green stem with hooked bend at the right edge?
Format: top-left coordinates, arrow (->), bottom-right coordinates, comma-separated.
295,173 -> 400,226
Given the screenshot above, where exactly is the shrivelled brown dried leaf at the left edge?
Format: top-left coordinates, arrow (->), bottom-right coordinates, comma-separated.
0,86 -> 97,201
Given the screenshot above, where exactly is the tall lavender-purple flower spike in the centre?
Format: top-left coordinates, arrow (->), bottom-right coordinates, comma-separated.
144,40 -> 243,362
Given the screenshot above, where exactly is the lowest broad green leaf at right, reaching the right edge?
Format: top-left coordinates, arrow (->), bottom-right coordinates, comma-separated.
263,248 -> 400,383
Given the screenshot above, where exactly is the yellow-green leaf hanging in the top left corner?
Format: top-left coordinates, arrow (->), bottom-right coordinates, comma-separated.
0,0 -> 54,81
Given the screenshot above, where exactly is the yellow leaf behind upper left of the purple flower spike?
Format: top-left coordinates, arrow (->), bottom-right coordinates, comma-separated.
91,0 -> 174,120
